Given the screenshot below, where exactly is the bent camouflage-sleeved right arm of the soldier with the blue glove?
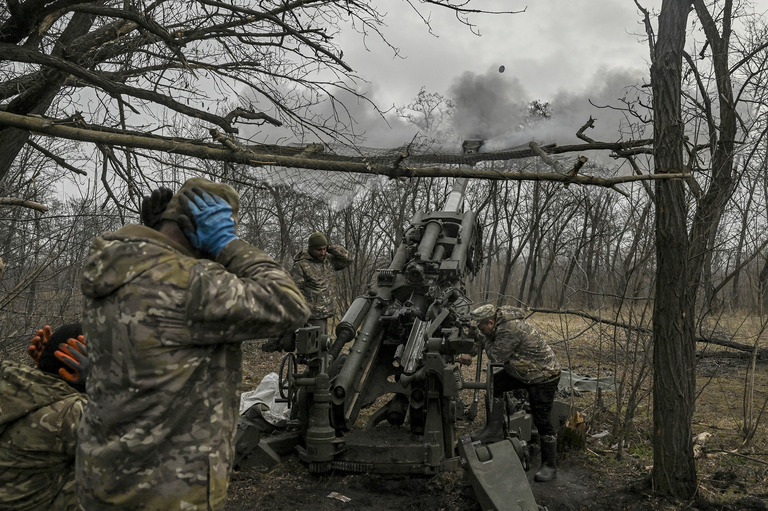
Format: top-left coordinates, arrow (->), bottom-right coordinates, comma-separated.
186,239 -> 310,343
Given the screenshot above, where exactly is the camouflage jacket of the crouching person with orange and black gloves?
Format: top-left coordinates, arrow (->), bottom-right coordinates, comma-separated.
0,360 -> 86,511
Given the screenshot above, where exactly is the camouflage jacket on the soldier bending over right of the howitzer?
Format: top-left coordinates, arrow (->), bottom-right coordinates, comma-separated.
485,306 -> 560,384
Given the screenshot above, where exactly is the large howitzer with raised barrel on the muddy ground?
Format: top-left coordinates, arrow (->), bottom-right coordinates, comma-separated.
237,179 -> 556,511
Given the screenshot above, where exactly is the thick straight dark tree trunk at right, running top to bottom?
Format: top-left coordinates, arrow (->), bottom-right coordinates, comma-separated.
651,0 -> 697,500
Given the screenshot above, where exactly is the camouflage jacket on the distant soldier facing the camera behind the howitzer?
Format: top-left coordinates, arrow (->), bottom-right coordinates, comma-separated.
291,245 -> 353,319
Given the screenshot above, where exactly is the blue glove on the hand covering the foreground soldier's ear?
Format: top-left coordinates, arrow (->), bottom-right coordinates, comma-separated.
179,186 -> 237,257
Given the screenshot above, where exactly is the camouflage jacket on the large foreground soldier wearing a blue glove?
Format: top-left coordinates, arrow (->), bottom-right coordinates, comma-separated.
77,225 -> 309,511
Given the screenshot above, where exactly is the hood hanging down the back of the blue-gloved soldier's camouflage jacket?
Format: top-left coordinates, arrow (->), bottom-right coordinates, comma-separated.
80,224 -> 195,299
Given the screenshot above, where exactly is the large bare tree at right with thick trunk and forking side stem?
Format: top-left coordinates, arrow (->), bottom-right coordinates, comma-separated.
646,0 -> 765,499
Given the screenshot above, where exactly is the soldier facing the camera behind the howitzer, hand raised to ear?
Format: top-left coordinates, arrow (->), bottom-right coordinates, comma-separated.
291,232 -> 353,334
